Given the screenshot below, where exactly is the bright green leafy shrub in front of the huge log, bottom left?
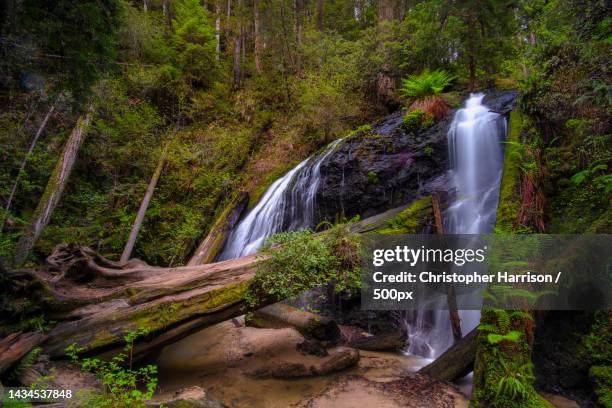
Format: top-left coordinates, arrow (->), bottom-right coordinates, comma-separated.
66,327 -> 157,408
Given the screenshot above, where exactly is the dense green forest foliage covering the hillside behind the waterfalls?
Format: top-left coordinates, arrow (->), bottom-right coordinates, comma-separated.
0,0 -> 612,406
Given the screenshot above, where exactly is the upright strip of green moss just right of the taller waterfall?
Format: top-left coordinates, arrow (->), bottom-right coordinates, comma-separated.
495,109 -> 525,233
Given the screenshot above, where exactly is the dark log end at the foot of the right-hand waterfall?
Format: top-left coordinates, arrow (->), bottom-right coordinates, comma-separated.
419,328 -> 478,381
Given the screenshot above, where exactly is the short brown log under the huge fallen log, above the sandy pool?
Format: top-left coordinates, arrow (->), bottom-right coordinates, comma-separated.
246,303 -> 340,342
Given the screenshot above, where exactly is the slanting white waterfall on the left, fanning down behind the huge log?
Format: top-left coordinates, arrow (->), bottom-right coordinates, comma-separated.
219,139 -> 341,260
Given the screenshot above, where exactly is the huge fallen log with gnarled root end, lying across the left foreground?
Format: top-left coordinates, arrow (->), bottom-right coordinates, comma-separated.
11,199 -> 430,359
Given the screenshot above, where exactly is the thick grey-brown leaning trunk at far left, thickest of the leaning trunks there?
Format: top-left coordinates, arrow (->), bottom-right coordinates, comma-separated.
15,104 -> 93,266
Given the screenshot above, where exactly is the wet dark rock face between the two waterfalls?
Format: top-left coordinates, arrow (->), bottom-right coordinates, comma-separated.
315,91 -> 517,222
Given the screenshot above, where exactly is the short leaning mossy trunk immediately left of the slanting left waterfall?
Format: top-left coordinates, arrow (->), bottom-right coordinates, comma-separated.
187,192 -> 249,266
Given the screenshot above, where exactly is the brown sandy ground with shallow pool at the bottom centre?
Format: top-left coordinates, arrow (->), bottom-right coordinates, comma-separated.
156,321 -> 468,408
